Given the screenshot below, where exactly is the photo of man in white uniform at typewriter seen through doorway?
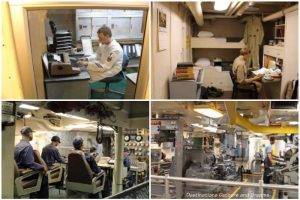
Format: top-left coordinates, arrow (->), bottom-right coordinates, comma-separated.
1,1 -> 150,99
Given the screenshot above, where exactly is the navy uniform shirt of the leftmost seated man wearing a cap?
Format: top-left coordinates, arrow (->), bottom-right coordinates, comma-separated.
15,139 -> 43,170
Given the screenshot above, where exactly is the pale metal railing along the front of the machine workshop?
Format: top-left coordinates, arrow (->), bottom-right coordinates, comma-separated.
151,175 -> 298,199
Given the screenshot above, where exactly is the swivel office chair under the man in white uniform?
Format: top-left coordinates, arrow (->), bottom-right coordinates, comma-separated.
92,53 -> 129,97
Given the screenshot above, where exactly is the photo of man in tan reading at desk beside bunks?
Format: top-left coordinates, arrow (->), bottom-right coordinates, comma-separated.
151,0 -> 298,99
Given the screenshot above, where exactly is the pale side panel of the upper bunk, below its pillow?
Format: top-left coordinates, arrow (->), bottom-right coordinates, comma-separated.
191,37 -> 245,49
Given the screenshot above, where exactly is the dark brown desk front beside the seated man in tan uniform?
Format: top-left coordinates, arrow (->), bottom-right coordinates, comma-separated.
261,78 -> 281,99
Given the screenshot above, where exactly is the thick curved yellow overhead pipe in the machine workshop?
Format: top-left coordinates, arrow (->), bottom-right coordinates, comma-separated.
224,101 -> 298,134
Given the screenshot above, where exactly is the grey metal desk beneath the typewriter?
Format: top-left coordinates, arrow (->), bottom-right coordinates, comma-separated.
44,71 -> 90,99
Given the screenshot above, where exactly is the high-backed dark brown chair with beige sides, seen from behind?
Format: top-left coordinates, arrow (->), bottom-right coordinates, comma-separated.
66,150 -> 105,194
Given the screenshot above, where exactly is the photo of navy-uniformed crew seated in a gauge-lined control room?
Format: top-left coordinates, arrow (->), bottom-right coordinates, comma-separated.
1,101 -> 149,199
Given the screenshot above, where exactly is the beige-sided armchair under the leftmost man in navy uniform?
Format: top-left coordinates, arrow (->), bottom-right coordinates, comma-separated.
14,162 -> 43,197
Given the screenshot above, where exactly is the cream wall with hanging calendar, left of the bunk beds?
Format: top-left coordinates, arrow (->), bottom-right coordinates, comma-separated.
151,2 -> 192,99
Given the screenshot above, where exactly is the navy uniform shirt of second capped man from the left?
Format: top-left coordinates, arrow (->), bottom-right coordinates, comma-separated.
42,144 -> 65,166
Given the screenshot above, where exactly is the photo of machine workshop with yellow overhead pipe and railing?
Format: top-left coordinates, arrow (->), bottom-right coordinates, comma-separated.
150,101 -> 299,199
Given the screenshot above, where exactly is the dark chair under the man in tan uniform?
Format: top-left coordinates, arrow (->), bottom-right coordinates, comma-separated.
229,69 -> 258,99
